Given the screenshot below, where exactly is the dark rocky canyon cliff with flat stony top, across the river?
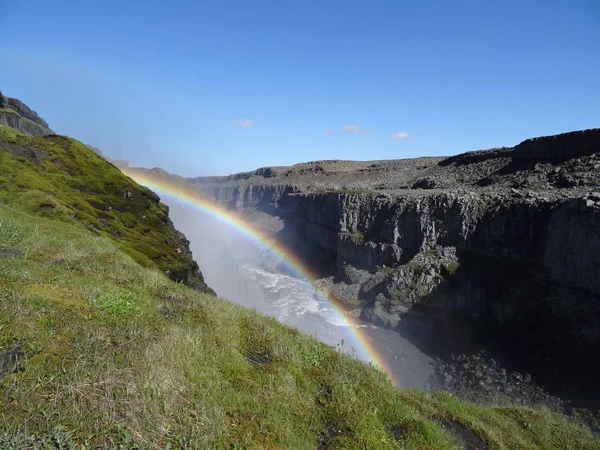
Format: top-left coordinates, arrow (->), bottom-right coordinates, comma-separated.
189,129 -> 600,400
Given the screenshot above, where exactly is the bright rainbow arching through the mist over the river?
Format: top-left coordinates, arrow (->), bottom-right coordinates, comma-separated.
121,168 -> 395,382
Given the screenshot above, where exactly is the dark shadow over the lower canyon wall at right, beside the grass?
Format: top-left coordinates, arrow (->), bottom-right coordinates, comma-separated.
378,254 -> 600,409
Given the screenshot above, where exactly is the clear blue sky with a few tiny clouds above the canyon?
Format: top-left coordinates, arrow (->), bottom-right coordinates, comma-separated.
0,0 -> 600,176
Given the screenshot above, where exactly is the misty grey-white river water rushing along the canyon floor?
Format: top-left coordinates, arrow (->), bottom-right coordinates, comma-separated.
163,199 -> 433,388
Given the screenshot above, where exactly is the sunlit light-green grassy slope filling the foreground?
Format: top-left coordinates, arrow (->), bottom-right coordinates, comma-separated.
0,205 -> 600,449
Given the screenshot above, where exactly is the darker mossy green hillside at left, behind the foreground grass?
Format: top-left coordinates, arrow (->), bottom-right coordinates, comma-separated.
0,126 -> 211,287
